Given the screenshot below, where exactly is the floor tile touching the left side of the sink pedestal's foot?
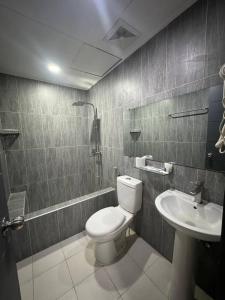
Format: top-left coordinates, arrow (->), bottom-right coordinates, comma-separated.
145,257 -> 172,295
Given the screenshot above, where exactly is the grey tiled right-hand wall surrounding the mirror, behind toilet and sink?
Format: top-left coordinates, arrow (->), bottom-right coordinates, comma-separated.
90,0 -> 225,294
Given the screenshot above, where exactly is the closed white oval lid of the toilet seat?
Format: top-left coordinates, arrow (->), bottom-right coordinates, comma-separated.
86,207 -> 125,236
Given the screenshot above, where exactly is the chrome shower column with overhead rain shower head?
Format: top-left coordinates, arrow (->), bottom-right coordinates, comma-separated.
72,100 -> 102,185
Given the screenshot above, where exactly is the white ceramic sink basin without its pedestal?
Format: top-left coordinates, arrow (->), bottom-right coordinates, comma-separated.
155,190 -> 223,242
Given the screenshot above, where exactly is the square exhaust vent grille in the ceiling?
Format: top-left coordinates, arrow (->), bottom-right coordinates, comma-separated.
103,19 -> 140,49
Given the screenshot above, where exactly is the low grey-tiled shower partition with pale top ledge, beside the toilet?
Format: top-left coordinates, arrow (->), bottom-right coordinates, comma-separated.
13,188 -> 116,261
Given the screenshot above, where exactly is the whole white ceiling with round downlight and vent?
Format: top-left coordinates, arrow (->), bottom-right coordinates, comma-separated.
0,0 -> 195,89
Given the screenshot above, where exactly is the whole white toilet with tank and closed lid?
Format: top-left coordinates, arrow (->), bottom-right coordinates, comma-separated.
85,175 -> 142,265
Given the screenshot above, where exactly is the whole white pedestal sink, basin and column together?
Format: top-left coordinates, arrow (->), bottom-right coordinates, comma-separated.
155,190 -> 223,300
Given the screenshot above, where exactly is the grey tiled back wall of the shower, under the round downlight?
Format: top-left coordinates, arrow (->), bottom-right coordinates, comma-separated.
0,74 -> 95,212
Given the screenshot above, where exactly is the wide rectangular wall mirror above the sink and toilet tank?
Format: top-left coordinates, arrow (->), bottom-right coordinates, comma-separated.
123,86 -> 225,171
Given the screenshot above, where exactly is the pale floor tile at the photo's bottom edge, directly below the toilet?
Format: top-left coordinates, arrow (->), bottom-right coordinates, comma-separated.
76,268 -> 120,300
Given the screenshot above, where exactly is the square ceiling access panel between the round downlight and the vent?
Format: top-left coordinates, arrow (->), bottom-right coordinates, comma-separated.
72,44 -> 120,76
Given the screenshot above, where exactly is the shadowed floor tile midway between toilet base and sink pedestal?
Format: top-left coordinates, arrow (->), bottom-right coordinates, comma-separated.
128,238 -> 161,270
